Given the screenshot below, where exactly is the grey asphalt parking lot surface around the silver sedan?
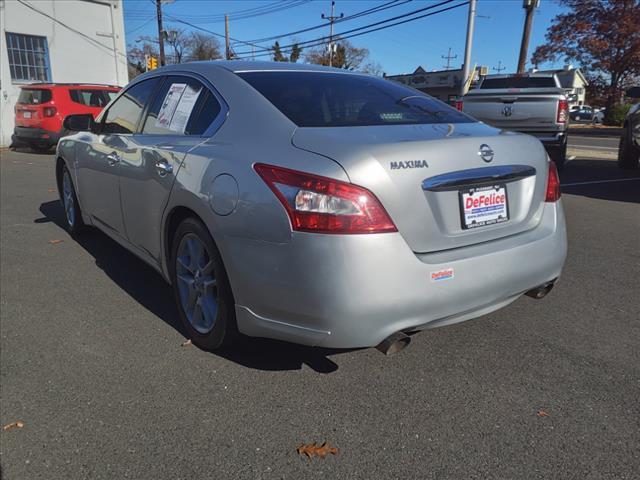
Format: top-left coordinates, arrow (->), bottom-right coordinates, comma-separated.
0,139 -> 640,480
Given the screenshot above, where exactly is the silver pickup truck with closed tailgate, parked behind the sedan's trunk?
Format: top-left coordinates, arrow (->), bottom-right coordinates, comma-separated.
462,73 -> 569,169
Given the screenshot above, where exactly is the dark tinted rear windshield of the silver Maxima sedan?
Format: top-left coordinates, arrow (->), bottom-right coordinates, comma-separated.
238,72 -> 475,127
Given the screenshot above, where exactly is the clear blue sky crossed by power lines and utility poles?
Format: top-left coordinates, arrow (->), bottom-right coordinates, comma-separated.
124,0 -> 562,75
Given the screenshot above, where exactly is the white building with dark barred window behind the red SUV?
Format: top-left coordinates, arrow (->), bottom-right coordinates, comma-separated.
0,0 -> 128,146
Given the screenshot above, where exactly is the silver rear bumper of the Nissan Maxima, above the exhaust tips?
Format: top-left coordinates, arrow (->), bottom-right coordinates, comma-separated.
228,202 -> 567,348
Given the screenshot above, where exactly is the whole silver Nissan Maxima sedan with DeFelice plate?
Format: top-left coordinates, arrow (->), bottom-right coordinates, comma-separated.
56,62 -> 567,353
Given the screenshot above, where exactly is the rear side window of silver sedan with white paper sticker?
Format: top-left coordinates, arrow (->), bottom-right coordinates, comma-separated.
142,76 -> 221,135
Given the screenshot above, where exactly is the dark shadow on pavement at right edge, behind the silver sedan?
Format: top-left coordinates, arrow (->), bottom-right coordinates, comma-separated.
560,158 -> 640,203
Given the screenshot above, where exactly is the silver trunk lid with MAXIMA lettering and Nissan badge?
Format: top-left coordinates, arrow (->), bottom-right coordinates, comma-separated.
292,123 -> 547,253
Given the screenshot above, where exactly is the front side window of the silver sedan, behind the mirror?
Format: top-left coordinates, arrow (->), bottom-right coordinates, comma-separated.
102,77 -> 159,134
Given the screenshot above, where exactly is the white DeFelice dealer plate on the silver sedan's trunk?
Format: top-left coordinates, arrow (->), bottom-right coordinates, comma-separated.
459,184 -> 509,230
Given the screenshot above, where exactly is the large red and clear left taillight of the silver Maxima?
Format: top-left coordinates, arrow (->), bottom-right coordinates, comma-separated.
253,163 -> 398,234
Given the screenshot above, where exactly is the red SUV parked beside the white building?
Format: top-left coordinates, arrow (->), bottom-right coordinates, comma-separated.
12,83 -> 120,151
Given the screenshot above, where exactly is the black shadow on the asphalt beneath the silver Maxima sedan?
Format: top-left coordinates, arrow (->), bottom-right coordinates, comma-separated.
34,200 -> 350,373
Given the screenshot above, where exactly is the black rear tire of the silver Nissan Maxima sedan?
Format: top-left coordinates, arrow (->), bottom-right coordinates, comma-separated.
169,218 -> 239,351
